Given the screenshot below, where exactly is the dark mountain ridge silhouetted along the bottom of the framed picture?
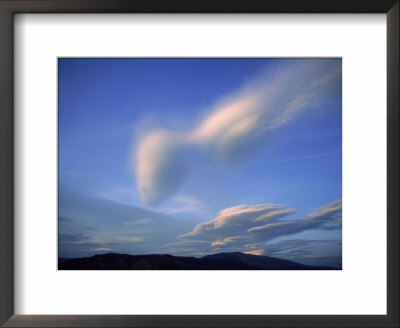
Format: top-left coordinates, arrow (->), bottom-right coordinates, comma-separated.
58,252 -> 337,270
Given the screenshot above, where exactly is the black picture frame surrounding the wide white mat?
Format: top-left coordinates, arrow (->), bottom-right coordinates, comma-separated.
0,0 -> 400,327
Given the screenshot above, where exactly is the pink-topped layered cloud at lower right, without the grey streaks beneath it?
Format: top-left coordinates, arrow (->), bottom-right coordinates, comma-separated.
180,200 -> 342,249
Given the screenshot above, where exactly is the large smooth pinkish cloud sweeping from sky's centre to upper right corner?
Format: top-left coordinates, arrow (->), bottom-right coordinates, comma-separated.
135,59 -> 341,204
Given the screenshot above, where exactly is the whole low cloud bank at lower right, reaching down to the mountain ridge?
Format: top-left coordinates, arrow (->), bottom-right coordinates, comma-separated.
165,200 -> 342,258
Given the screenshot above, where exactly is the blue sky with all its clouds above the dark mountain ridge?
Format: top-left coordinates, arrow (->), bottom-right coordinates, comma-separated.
58,58 -> 342,267
